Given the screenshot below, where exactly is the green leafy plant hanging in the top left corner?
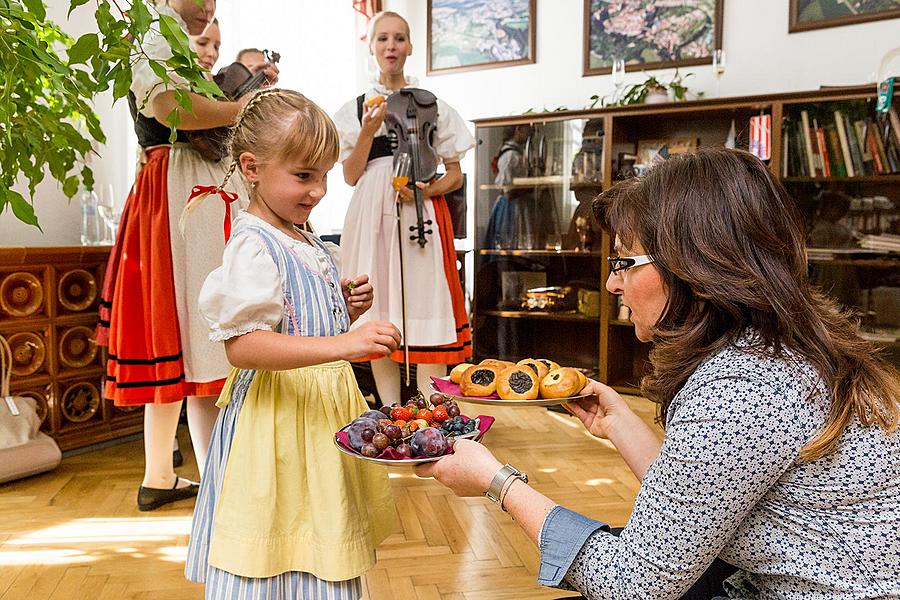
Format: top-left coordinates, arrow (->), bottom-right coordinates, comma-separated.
0,0 -> 221,228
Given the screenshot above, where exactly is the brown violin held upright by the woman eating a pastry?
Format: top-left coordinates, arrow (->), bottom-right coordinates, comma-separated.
384,88 -> 438,248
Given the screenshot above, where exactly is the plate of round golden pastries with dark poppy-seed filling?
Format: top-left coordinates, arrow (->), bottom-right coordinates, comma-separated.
432,358 -> 589,406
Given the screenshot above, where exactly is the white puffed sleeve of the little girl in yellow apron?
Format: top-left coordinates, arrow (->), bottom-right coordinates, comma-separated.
200,232 -> 284,342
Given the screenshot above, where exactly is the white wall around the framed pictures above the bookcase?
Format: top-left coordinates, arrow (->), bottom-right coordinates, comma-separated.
394,0 -> 900,119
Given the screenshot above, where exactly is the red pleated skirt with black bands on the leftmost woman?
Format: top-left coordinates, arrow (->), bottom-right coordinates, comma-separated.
97,146 -> 225,406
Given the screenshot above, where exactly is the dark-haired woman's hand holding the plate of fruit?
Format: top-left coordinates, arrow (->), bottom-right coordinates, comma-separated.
416,440 -> 503,496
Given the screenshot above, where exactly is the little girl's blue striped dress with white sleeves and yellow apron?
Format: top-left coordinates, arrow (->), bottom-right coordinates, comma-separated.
185,212 -> 396,600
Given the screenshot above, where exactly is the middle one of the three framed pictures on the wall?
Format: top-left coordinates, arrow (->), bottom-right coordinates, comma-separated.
583,0 -> 723,75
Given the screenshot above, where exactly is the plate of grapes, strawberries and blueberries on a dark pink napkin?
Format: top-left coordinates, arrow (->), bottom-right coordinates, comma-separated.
334,393 -> 494,465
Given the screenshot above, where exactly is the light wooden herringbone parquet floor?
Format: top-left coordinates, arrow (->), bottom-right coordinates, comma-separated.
0,398 -> 653,600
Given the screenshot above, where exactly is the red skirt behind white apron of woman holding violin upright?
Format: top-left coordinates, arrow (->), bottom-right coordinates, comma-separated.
365,195 -> 472,365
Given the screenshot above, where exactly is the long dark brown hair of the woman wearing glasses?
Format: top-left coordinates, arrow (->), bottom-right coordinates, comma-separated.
594,148 -> 900,461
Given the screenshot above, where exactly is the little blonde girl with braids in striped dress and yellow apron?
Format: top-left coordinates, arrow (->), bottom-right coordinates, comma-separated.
185,90 -> 400,600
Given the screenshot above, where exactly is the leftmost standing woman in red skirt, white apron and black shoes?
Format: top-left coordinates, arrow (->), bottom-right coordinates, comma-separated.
97,0 -> 275,510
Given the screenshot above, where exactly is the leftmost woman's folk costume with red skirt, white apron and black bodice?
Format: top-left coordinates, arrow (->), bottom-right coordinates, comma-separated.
97,6 -> 247,406
